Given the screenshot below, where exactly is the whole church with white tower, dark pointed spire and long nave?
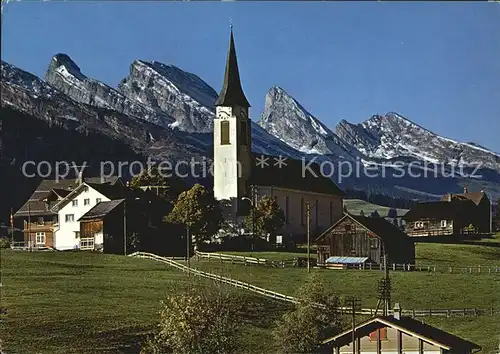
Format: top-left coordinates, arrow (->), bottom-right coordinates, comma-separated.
213,28 -> 344,241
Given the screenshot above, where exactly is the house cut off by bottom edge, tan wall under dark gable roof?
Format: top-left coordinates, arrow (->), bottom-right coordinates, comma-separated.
322,304 -> 481,354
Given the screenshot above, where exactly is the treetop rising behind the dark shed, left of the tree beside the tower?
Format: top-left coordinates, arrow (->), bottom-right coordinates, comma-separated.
130,166 -> 188,203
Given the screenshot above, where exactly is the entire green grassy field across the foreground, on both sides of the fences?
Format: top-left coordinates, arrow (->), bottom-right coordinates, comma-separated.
0,238 -> 500,354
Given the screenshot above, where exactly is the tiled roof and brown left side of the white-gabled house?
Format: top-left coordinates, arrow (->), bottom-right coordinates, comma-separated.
13,177 -> 124,247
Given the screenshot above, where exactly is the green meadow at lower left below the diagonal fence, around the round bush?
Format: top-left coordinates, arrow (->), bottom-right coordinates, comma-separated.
0,251 -> 288,354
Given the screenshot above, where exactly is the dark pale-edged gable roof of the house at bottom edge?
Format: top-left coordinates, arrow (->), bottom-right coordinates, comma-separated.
323,316 -> 481,352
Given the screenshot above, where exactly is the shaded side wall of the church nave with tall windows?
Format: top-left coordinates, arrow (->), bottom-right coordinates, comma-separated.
257,186 -> 343,242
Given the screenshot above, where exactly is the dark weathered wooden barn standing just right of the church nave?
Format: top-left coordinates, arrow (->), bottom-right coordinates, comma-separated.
316,214 -> 415,265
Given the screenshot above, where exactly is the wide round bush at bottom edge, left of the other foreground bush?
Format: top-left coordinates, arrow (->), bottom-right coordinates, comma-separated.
142,286 -> 240,354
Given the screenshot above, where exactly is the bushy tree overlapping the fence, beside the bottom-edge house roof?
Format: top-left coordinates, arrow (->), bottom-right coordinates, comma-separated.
273,274 -> 342,353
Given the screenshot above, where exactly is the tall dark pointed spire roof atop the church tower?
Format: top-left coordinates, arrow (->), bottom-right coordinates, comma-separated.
215,25 -> 250,108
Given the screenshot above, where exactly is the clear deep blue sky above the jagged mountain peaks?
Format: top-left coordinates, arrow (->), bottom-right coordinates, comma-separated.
2,1 -> 500,152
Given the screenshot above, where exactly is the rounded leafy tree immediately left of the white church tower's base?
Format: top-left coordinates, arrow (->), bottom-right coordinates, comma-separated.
167,184 -> 222,245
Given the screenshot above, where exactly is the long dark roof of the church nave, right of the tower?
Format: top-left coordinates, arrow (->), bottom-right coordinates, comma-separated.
249,153 -> 345,196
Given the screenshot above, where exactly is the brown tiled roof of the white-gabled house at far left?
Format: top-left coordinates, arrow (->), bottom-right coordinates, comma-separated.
14,176 -> 121,217
